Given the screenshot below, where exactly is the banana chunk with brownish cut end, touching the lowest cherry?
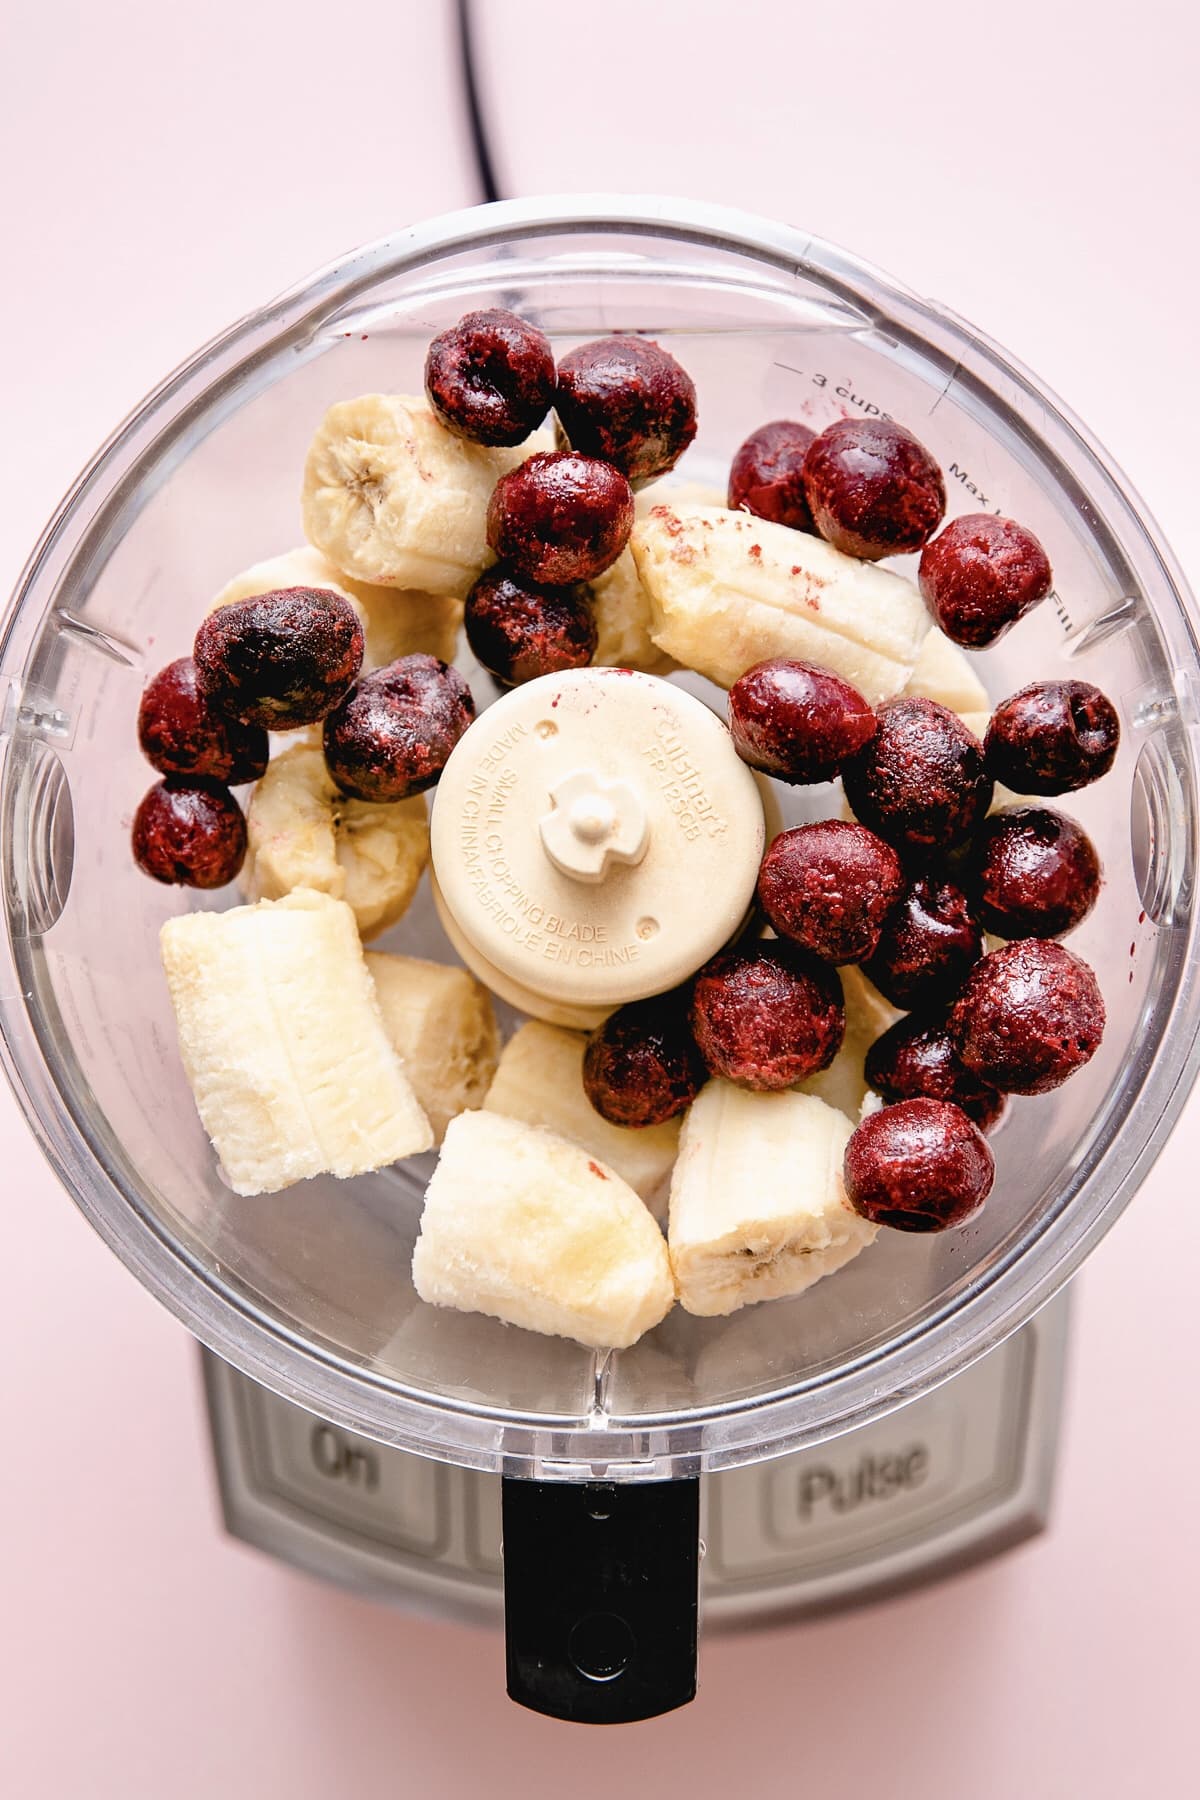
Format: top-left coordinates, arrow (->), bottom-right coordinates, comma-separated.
667,1082 -> 878,1318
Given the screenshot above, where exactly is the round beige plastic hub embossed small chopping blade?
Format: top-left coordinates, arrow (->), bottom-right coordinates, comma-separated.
430,668 -> 766,1010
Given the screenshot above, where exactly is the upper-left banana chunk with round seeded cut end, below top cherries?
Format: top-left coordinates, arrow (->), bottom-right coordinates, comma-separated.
300,394 -> 529,599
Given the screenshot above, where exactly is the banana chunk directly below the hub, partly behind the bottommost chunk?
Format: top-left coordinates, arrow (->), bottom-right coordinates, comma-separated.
484,1019 -> 682,1202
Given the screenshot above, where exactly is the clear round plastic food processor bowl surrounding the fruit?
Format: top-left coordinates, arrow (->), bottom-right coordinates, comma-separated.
0,196 -> 1200,1480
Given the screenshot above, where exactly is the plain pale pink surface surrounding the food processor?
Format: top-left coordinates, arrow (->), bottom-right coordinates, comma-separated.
0,0 -> 1200,1800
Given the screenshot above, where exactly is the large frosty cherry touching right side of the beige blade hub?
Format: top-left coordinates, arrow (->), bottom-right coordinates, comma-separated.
757,819 -> 905,963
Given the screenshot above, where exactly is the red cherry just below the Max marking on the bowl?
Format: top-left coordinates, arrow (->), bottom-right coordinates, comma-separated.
919,513 -> 1054,650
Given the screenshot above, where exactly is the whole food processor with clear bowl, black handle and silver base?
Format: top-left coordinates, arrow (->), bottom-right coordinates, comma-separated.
0,196 -> 1200,1721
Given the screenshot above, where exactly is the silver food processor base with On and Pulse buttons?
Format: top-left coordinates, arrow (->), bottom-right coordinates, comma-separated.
201,1292 -> 1069,1629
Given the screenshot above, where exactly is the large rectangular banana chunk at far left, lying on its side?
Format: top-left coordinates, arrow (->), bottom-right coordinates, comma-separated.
160,889 -> 434,1193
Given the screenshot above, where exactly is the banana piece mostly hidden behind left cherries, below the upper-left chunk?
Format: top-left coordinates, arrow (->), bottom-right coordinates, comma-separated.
209,544 -> 462,668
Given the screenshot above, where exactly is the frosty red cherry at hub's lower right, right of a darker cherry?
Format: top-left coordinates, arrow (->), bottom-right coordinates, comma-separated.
691,943 -> 846,1093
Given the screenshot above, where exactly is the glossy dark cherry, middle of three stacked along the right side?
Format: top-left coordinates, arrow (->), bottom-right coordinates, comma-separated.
972,806 -> 1099,938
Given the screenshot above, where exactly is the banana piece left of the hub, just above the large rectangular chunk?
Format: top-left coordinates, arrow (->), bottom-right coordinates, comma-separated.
241,743 -> 430,938
